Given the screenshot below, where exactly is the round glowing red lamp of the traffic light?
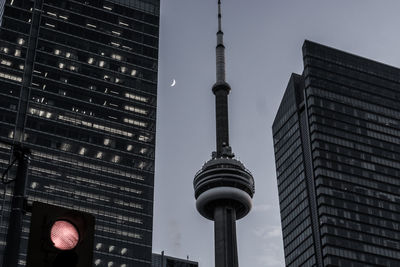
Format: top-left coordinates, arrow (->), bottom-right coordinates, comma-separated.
50,220 -> 79,250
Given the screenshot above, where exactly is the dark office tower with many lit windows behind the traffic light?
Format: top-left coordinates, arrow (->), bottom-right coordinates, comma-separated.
0,0 -> 160,267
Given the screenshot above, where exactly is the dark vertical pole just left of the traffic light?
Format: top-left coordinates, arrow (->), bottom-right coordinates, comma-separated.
3,145 -> 31,267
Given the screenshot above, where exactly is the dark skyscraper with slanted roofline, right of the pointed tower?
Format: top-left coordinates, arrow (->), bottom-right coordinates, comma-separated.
272,41 -> 400,266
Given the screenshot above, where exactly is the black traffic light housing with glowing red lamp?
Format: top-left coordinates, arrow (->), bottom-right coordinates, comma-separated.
26,202 -> 94,267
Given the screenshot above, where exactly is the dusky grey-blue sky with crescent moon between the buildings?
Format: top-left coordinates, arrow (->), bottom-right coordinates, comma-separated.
153,0 -> 400,267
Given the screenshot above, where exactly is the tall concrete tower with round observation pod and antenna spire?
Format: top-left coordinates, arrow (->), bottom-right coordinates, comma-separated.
193,0 -> 254,267
